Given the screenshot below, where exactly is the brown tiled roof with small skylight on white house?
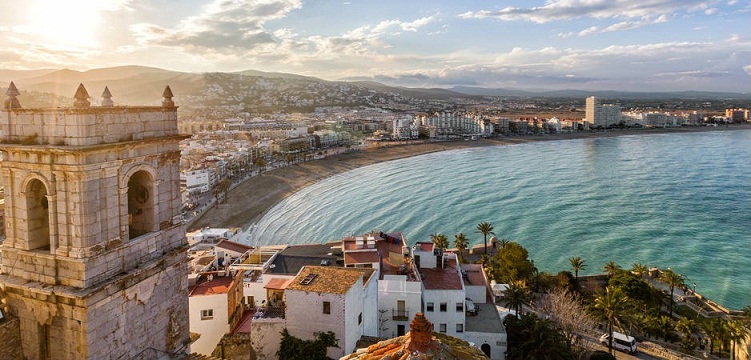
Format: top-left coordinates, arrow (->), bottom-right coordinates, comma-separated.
286,266 -> 374,294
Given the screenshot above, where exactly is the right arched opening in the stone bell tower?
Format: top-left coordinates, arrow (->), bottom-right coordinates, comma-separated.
128,171 -> 156,239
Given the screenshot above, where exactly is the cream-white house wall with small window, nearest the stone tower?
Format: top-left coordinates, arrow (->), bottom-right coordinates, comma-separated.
188,293 -> 230,355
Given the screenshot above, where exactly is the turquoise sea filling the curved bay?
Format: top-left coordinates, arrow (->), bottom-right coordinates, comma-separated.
246,130 -> 751,308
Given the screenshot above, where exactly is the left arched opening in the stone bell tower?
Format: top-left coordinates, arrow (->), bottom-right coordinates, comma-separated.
26,179 -> 50,250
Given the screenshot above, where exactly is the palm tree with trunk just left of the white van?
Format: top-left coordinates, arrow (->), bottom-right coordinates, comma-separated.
591,286 -> 634,354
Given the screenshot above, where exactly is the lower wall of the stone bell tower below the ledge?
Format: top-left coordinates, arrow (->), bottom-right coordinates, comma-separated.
3,249 -> 189,359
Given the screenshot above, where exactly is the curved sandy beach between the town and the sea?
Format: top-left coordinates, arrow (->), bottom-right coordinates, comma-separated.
188,124 -> 751,230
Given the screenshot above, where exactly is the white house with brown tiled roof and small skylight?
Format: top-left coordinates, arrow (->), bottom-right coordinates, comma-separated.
284,266 -> 378,358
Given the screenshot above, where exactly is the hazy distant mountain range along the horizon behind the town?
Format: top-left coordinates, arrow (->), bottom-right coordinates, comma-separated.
0,66 -> 751,105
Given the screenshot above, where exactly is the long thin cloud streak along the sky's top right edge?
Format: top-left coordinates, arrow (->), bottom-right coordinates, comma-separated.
459,0 -> 717,23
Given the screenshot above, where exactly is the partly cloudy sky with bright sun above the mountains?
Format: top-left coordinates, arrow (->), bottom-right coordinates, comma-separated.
0,0 -> 751,93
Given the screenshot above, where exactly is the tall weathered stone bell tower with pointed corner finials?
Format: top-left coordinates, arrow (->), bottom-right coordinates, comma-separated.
0,85 -> 189,359
